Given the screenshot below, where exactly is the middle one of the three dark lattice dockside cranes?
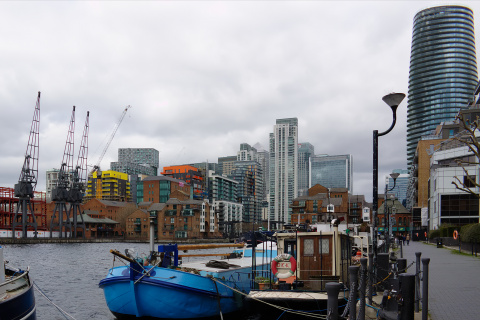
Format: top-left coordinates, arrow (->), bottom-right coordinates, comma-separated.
50,106 -> 75,238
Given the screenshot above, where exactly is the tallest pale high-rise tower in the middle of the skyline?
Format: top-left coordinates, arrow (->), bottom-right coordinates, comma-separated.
269,118 -> 298,228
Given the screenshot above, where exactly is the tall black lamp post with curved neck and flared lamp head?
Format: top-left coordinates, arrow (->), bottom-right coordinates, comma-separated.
372,93 -> 405,278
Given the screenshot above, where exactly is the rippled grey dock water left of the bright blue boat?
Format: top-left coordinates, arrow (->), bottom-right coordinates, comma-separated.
2,243 -> 231,320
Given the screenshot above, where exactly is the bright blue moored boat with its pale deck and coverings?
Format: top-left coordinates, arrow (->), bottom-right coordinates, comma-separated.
99,244 -> 276,319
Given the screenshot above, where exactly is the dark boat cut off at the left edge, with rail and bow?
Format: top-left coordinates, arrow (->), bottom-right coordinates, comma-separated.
0,246 -> 36,320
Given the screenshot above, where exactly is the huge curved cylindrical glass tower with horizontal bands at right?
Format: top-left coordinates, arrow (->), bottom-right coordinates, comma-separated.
407,6 -> 477,169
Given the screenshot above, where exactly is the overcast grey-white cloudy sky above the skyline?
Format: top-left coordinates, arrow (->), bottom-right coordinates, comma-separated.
0,1 -> 480,201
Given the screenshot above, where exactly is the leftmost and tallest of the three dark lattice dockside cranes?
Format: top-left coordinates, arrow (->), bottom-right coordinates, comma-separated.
12,92 -> 40,238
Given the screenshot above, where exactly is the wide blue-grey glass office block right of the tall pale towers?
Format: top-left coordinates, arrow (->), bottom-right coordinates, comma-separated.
310,154 -> 353,193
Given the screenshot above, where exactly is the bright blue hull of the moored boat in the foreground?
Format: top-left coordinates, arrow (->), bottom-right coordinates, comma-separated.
99,266 -> 260,319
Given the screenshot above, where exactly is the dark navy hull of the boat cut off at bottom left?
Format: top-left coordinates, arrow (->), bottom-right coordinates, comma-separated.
0,283 -> 37,320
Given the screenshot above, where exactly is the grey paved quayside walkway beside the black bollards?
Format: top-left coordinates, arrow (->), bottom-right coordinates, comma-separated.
398,241 -> 480,320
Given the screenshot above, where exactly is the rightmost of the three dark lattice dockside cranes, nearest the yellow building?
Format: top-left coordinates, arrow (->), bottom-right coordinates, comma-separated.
68,111 -> 90,238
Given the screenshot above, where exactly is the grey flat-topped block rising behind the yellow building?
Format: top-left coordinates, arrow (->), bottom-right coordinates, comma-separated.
110,148 -> 159,176
